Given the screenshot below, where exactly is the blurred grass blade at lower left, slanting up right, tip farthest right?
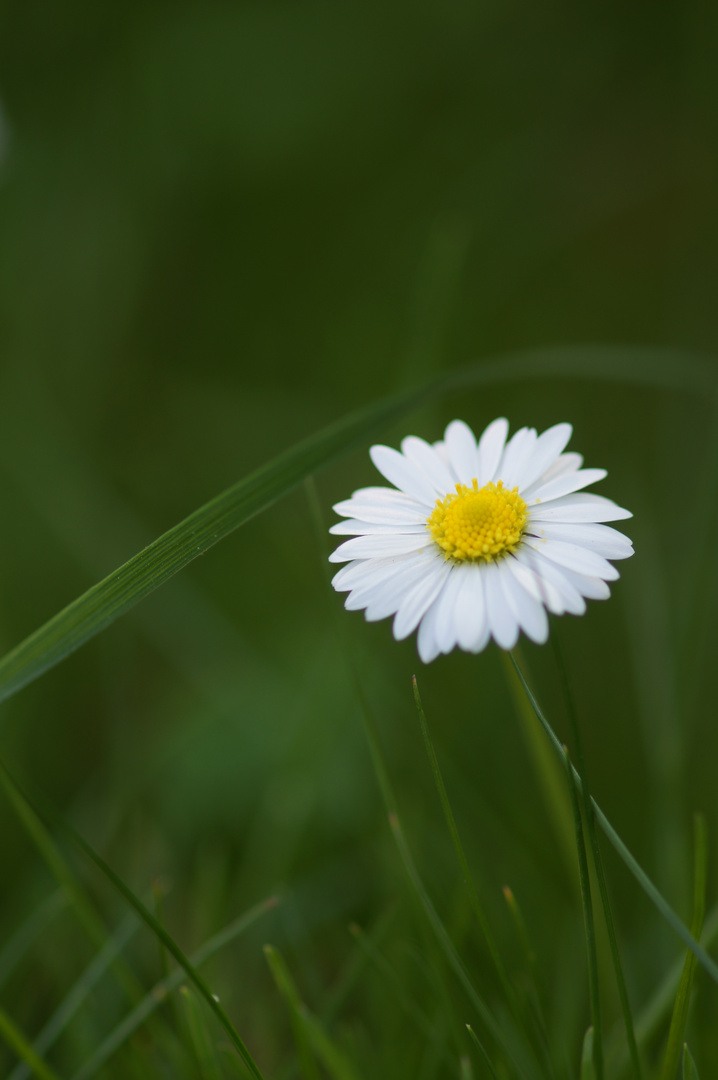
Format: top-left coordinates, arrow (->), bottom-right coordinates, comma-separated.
72,896 -> 279,1080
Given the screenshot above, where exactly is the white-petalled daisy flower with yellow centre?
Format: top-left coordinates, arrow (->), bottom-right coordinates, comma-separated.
329,419 -> 633,663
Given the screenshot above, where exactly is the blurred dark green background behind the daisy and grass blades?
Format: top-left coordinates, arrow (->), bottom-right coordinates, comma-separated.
0,0 -> 718,1077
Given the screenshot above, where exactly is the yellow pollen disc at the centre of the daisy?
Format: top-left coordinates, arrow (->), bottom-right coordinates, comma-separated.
426,480 -> 526,563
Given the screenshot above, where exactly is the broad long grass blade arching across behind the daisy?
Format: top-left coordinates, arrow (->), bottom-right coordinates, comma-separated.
0,348 -> 716,701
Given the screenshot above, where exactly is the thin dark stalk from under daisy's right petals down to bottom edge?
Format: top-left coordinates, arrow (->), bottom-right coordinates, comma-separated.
552,633 -> 639,1080
